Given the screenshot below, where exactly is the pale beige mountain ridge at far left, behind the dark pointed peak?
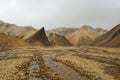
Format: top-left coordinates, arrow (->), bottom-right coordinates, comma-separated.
0,21 -> 37,40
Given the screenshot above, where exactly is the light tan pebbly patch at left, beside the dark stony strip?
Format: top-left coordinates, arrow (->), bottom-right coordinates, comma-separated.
0,53 -> 33,80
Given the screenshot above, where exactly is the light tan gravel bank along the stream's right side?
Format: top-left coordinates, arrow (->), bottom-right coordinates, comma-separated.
56,54 -> 114,80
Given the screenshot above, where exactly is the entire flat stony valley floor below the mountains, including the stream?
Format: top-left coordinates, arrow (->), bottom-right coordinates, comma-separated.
0,46 -> 120,80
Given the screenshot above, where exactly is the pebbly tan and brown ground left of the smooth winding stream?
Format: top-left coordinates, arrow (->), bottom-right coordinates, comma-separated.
0,48 -> 62,80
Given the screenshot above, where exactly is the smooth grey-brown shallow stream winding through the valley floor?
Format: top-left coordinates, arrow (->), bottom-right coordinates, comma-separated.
43,51 -> 89,80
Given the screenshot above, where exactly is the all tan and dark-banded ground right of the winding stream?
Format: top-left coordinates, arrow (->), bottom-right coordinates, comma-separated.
55,48 -> 120,80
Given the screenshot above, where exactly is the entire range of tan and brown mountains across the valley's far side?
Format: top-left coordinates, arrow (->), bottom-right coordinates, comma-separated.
0,21 -> 120,47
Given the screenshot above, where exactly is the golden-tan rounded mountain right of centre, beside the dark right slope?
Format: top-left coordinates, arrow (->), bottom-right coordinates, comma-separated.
66,25 -> 99,46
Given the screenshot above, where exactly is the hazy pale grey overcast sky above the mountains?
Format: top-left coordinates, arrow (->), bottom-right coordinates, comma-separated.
0,0 -> 120,29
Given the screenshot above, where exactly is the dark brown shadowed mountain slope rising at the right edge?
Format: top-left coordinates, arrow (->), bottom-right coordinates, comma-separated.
93,24 -> 120,47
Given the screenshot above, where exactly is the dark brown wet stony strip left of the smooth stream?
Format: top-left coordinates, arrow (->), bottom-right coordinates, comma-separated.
17,54 -> 62,80
